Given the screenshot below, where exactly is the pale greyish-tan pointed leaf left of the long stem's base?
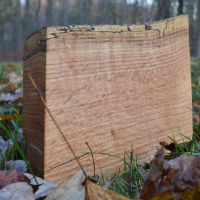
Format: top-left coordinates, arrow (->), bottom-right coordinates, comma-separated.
45,168 -> 86,200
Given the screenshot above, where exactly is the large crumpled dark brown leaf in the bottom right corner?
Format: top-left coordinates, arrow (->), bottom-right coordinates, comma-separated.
141,150 -> 200,200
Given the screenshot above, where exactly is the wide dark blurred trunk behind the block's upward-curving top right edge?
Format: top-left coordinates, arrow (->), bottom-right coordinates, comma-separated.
156,0 -> 171,20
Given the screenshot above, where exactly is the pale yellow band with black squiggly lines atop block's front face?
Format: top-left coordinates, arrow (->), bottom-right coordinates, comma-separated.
47,15 -> 189,40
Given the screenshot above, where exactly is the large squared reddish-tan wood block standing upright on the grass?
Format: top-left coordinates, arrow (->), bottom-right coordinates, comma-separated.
23,16 -> 192,182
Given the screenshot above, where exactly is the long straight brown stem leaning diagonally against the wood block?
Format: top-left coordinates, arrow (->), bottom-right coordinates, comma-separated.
27,71 -> 88,179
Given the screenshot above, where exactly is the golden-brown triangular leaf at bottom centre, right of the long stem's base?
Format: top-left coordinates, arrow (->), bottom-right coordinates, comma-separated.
85,180 -> 128,200
